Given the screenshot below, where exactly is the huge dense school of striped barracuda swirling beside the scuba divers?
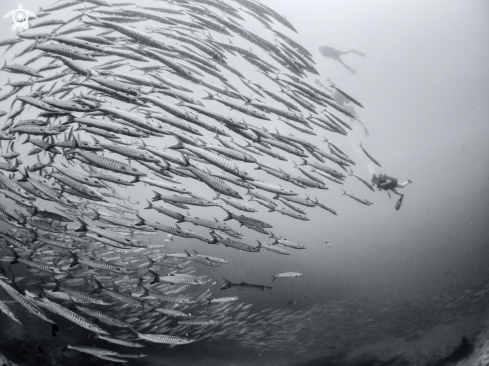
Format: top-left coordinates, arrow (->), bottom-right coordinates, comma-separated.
0,0 -> 396,362
